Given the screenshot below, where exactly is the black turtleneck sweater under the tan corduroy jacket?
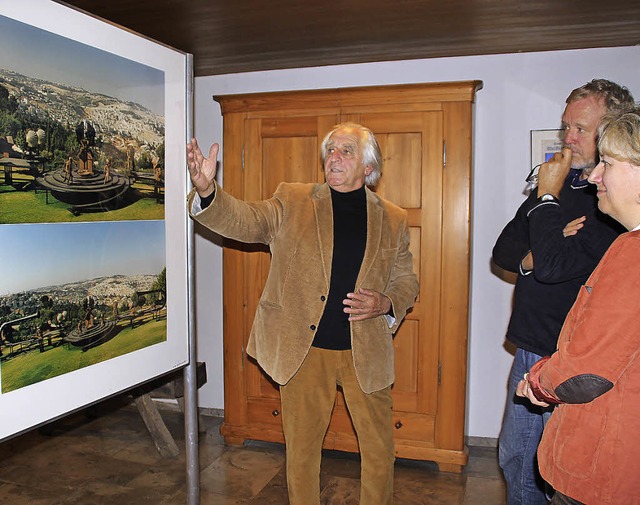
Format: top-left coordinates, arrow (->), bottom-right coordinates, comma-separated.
313,186 -> 367,350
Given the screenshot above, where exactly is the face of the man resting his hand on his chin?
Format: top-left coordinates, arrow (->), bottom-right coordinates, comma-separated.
562,96 -> 607,173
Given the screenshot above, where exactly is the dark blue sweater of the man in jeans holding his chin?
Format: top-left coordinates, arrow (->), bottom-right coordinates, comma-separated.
493,175 -> 623,356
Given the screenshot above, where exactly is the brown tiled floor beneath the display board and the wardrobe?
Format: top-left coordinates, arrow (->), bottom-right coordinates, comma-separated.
0,400 -> 505,505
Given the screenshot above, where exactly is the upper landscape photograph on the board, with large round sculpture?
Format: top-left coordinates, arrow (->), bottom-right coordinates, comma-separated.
0,15 -> 165,224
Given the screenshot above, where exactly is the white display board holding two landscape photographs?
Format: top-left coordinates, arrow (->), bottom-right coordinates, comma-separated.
0,0 -> 192,440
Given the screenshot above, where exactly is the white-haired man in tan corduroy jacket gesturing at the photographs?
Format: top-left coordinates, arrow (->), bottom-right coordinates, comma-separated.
187,123 -> 418,505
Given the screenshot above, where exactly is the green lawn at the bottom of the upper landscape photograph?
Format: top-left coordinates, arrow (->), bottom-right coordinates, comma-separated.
0,184 -> 164,220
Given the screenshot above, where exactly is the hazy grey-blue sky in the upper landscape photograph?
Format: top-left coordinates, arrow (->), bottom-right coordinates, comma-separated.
0,12 -> 164,116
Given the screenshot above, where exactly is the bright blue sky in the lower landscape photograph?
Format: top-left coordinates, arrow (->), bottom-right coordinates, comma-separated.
0,221 -> 166,296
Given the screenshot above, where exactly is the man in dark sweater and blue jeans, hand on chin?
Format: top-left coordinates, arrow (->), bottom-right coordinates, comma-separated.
493,79 -> 634,505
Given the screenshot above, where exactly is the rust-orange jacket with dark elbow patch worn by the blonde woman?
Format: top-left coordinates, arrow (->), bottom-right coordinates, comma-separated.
529,231 -> 640,505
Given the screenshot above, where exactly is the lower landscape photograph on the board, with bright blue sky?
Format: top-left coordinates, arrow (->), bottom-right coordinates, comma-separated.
0,220 -> 167,394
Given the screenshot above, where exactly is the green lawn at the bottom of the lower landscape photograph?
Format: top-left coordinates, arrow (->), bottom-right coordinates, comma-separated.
1,319 -> 167,393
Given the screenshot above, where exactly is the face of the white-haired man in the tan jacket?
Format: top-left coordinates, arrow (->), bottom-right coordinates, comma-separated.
324,128 -> 372,193
